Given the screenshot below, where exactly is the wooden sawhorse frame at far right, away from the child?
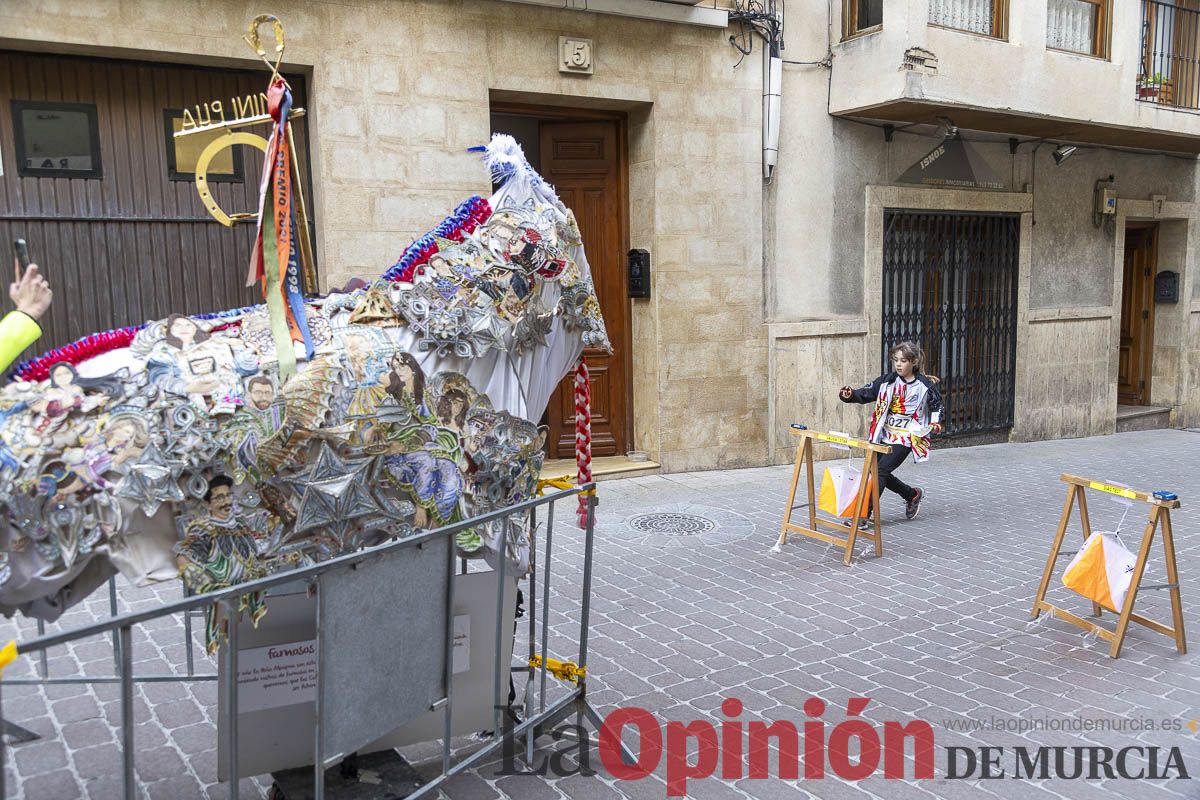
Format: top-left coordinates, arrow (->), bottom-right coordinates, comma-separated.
1033,474 -> 1188,658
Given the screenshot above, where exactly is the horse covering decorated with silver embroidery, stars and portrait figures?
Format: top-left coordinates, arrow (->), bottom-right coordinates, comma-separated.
0,136 -> 608,646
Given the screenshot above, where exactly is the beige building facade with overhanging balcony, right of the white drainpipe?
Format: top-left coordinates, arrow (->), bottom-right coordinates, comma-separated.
766,0 -> 1200,461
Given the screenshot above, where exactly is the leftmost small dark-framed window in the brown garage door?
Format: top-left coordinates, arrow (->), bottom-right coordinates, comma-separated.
12,100 -> 102,178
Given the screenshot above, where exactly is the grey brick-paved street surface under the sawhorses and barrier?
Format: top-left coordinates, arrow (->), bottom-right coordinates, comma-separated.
0,431 -> 1200,800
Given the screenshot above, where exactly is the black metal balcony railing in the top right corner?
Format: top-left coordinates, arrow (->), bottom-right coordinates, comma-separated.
1136,0 -> 1200,108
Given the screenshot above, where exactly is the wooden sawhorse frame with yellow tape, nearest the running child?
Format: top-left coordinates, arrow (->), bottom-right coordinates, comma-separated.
772,426 -> 892,566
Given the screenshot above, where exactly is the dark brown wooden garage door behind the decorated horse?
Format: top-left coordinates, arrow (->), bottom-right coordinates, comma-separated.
0,50 -> 312,351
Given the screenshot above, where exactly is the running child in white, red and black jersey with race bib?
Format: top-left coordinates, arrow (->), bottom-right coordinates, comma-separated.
839,342 -> 942,519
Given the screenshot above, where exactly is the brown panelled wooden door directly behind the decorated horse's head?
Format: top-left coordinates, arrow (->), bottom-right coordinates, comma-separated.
540,120 -> 632,458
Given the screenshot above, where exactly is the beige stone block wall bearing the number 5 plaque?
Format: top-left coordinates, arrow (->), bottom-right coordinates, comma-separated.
0,0 -> 768,471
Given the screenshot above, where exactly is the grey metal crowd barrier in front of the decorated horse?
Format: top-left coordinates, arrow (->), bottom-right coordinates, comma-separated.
0,483 -> 604,800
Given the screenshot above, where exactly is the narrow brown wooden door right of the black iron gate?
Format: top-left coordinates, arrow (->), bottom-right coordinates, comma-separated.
1117,228 -> 1158,405
